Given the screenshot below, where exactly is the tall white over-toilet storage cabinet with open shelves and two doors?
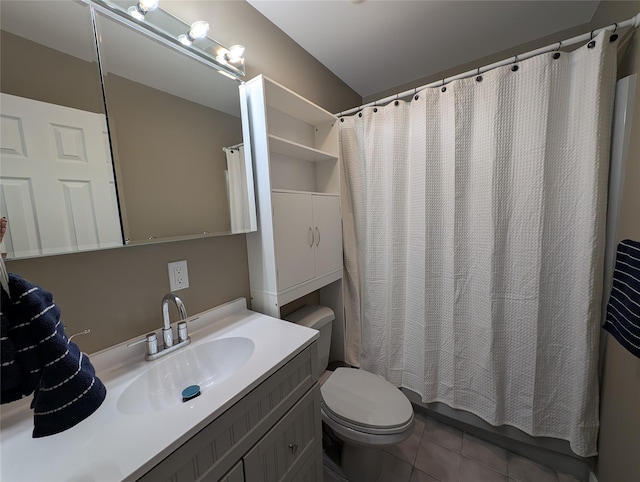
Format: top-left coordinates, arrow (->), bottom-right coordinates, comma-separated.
240,75 -> 342,318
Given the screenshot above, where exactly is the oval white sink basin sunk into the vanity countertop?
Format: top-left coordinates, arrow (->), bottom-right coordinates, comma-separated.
117,337 -> 255,415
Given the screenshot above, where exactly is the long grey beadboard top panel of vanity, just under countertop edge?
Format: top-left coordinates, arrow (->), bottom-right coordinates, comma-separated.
139,342 -> 318,482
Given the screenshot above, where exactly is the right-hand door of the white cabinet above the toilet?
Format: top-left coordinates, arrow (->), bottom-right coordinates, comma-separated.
313,195 -> 342,276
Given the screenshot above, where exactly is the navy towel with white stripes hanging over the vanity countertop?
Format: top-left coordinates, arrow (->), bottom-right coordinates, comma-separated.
0,273 -> 107,437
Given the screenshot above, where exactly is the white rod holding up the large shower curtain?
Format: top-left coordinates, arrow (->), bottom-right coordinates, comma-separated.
335,13 -> 640,117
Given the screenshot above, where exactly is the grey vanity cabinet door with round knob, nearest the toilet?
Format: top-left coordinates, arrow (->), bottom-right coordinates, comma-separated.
244,385 -> 322,482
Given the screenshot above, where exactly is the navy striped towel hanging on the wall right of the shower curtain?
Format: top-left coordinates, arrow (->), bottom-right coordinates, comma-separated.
603,239 -> 640,358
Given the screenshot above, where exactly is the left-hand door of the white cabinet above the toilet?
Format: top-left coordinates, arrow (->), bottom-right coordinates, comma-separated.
271,192 -> 315,291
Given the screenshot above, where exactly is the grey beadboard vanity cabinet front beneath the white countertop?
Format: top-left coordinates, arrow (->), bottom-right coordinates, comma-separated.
139,342 -> 322,482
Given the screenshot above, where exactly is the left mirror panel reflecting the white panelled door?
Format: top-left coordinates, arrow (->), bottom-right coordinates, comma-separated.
0,1 -> 122,258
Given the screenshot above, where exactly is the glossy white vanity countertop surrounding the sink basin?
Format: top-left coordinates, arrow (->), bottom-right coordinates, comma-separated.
0,298 -> 318,482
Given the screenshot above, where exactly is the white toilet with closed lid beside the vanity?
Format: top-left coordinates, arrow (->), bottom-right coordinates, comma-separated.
285,305 -> 414,482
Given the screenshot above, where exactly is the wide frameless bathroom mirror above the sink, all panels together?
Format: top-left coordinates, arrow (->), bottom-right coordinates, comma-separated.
0,0 -> 256,258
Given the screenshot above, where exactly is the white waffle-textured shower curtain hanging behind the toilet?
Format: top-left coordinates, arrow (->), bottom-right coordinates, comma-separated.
340,32 -> 616,456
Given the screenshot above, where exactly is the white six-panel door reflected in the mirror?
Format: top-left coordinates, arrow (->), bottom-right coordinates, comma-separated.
0,94 -> 122,257
